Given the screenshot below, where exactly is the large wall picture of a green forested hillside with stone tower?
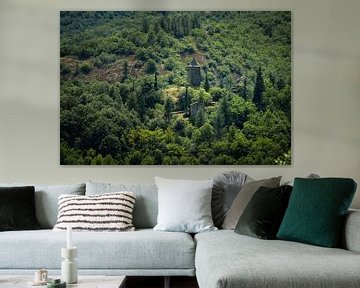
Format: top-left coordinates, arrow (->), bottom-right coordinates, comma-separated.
60,11 -> 291,165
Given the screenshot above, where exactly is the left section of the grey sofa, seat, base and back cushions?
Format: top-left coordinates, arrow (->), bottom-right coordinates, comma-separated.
0,182 -> 195,276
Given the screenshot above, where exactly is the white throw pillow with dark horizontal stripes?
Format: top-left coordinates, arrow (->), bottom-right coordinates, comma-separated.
54,191 -> 135,231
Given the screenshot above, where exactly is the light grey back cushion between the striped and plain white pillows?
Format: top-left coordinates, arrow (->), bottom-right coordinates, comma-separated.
85,181 -> 158,229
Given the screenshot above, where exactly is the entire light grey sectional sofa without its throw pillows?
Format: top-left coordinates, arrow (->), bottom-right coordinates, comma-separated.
0,182 -> 360,288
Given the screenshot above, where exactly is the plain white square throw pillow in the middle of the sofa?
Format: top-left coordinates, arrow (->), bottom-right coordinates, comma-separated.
154,177 -> 217,233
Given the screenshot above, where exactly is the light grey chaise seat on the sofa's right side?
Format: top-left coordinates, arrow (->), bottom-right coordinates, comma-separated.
195,230 -> 360,288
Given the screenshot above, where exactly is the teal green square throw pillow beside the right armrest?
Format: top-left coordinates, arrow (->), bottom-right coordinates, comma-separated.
277,178 -> 357,247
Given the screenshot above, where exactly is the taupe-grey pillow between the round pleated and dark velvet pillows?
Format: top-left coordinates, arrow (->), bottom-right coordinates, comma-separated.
222,176 -> 281,230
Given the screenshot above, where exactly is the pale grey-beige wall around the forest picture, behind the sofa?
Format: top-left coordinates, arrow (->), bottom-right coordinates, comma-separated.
0,0 -> 360,207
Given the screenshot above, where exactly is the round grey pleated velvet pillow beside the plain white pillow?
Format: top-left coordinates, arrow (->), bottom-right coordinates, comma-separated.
211,171 -> 252,228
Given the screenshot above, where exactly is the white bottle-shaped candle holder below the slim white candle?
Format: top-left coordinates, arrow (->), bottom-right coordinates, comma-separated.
61,247 -> 78,284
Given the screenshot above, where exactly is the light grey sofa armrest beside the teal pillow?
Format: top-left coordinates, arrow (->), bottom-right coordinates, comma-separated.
343,210 -> 360,253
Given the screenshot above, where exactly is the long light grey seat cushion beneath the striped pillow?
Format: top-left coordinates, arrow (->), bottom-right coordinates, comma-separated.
0,229 -> 195,270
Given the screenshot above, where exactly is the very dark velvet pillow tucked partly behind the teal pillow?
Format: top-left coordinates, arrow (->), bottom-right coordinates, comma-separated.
235,185 -> 292,239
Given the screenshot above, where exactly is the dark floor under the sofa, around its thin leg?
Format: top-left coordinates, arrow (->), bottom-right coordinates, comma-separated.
126,276 -> 199,288
